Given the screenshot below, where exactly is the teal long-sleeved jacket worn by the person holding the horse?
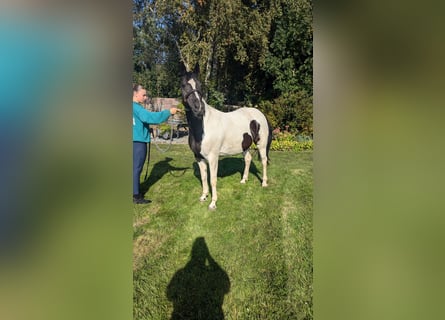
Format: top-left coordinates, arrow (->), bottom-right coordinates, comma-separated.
133,102 -> 170,142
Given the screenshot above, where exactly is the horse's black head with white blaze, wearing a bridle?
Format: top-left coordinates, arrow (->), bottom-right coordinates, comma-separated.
181,66 -> 205,118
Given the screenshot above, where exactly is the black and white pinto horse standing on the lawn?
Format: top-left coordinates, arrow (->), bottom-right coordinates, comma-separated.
181,67 -> 272,209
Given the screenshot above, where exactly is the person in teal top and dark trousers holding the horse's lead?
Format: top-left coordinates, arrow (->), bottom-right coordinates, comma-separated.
133,85 -> 178,204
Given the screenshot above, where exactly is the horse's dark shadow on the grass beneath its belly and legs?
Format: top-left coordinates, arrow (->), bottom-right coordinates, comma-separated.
193,157 -> 262,182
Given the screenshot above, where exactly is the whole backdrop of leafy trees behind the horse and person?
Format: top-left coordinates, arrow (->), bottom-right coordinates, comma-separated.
133,0 -> 313,134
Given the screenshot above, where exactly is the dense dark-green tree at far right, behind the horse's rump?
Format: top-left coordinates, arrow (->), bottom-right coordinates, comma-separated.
262,0 -> 313,135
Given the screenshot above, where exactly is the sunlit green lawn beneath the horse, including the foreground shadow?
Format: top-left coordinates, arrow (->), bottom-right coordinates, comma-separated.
133,145 -> 313,320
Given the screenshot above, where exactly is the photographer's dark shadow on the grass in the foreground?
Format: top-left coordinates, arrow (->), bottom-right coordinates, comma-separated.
166,237 -> 230,320
